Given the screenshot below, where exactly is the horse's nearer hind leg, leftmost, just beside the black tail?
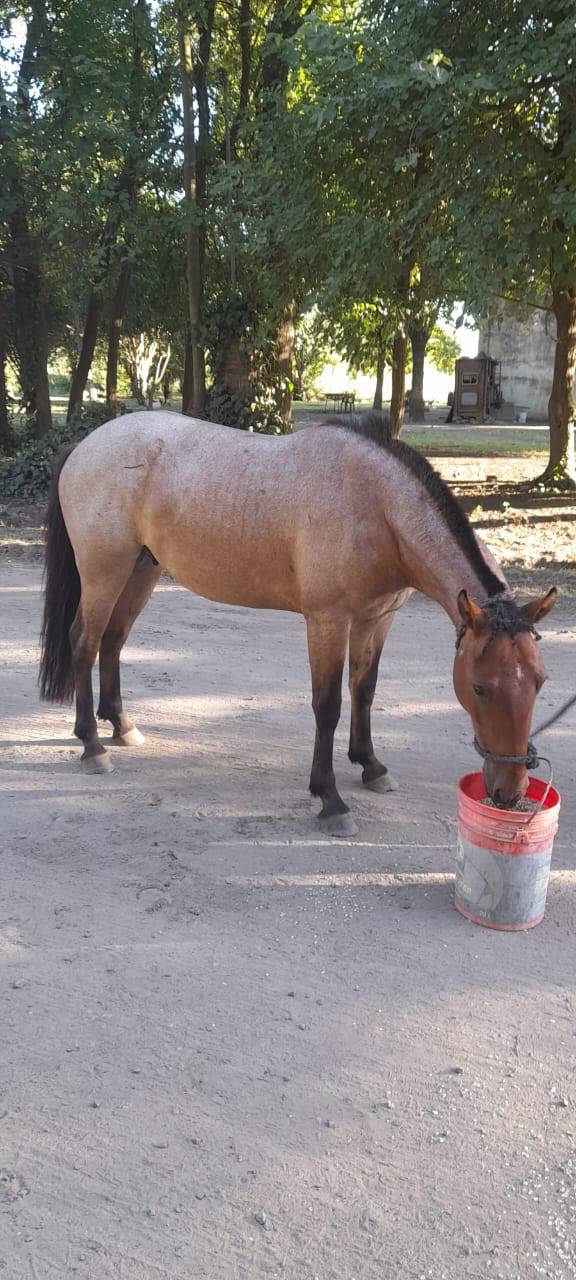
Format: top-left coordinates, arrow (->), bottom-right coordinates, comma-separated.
70,561 -> 133,773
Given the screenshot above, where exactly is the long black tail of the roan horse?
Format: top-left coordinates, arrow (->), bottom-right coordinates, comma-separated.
38,445 -> 81,703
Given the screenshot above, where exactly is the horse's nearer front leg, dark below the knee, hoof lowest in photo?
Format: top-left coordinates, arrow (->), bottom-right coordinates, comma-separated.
307,616 -> 355,835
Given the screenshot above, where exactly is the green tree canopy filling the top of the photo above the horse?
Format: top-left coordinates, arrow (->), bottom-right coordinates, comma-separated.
0,0 -> 576,484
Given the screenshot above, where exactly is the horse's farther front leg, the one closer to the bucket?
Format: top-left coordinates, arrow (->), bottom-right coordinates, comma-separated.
348,613 -> 398,791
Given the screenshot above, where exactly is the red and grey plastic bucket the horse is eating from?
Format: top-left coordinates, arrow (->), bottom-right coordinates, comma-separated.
454,773 -> 561,931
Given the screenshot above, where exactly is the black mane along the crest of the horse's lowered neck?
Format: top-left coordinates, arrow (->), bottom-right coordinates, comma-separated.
326,412 -> 506,604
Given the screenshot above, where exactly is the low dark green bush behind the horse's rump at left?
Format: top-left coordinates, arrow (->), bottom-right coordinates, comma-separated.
0,403 -> 122,502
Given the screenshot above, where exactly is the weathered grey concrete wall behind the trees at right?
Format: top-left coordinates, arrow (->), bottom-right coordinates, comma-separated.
479,310 -> 556,421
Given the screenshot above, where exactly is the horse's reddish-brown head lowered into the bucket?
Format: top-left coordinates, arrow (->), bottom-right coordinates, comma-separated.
454,588 -> 558,809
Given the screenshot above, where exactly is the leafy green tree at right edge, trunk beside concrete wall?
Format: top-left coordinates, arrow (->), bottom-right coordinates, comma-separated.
379,0 -> 576,488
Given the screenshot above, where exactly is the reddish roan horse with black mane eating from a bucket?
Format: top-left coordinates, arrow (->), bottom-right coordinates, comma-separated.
40,411 -> 557,835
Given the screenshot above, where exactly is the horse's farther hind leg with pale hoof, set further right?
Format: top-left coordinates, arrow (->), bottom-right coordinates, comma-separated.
96,552 -> 161,746
